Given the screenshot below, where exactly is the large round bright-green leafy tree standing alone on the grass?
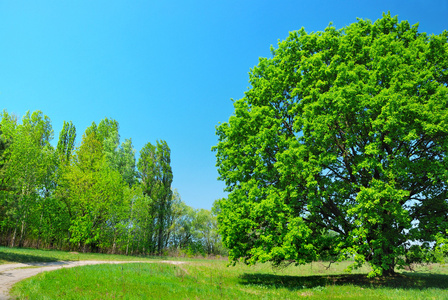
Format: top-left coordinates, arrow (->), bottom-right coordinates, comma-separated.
214,14 -> 448,275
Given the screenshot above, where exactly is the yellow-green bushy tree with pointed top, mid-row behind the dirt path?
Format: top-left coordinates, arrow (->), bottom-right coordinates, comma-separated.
58,131 -> 129,252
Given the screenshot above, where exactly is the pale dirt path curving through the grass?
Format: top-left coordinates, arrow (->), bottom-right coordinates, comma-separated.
0,260 -> 184,300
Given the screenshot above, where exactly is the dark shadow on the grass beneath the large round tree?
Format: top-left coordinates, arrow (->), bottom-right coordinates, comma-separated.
240,272 -> 448,290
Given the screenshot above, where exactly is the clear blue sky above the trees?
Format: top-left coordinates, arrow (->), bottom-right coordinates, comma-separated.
0,0 -> 448,209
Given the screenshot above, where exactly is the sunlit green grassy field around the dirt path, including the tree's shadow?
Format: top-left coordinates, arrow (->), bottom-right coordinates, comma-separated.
0,248 -> 448,300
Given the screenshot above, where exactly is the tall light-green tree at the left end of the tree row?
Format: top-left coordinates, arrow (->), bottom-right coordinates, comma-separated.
3,111 -> 54,247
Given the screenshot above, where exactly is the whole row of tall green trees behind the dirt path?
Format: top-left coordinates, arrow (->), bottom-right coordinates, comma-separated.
0,111 -> 223,254
